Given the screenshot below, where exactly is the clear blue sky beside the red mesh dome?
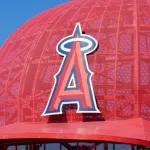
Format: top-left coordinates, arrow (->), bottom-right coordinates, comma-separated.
0,0 -> 70,46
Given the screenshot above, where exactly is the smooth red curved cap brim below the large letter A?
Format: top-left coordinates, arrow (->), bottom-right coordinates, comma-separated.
0,118 -> 150,146
